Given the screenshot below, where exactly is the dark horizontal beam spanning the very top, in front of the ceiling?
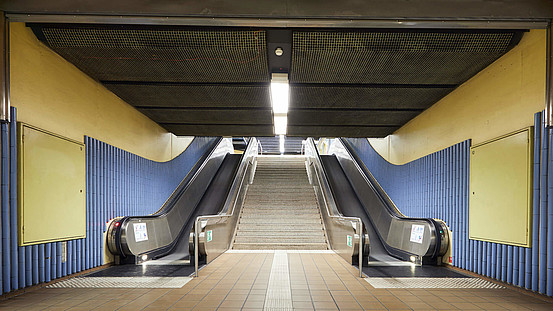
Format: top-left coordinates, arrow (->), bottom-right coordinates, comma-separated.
0,0 -> 553,22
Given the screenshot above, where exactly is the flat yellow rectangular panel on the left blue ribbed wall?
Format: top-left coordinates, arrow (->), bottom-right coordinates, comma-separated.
18,123 -> 86,245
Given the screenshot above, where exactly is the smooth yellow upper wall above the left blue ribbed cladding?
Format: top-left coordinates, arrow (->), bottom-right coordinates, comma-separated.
10,23 -> 192,161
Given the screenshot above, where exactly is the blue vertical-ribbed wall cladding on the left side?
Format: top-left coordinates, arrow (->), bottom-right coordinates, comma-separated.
0,108 -> 214,293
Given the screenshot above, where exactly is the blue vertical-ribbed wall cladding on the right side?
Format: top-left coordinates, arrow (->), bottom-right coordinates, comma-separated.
348,112 -> 553,296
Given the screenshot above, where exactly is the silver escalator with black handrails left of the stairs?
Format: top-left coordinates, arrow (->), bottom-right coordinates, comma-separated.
107,138 -> 257,265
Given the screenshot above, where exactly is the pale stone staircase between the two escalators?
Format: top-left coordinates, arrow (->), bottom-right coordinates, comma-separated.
233,157 -> 328,250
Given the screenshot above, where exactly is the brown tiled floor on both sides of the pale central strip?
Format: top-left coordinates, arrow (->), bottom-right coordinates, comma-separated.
0,253 -> 553,310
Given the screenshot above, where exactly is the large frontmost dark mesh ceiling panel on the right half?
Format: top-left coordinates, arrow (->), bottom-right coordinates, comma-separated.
290,31 -> 520,84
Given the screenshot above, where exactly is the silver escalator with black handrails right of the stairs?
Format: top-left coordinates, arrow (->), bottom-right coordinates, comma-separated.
306,139 -> 450,264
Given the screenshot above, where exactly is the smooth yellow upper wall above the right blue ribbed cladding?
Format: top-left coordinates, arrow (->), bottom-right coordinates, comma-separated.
369,29 -> 546,164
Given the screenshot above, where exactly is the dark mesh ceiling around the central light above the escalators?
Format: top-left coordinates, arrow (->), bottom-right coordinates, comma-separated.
28,24 -> 522,137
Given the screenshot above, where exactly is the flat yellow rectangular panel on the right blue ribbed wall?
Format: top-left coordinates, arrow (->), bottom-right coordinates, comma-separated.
469,128 -> 533,247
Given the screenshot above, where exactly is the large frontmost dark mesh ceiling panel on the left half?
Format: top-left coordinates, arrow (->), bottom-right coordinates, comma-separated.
35,25 -> 269,82
